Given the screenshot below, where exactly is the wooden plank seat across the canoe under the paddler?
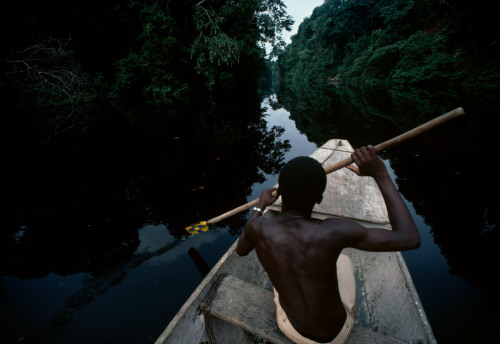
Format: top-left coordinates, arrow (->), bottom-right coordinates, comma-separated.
200,275 -> 402,344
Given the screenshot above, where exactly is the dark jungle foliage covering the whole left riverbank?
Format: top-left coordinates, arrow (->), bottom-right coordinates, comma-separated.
0,0 -> 293,151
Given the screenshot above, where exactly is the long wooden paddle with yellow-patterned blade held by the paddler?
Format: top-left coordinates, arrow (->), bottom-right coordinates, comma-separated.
186,107 -> 465,234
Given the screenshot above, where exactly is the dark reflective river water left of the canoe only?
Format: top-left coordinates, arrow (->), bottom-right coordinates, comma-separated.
0,92 -> 290,343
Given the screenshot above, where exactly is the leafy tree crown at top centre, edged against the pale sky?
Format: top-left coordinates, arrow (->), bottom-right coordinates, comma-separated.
191,0 -> 293,74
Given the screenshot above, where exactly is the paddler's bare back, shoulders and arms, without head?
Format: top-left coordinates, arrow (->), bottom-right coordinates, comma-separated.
236,146 -> 420,342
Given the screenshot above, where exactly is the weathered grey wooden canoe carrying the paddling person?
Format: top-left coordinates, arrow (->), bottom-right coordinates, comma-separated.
156,139 -> 436,344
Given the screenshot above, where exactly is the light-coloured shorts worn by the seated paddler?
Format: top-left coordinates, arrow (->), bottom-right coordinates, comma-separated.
274,254 -> 356,344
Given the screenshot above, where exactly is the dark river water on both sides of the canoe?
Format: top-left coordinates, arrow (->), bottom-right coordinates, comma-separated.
0,94 -> 500,344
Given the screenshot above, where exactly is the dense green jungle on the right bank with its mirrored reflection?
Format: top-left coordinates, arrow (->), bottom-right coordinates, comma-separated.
274,0 -> 500,142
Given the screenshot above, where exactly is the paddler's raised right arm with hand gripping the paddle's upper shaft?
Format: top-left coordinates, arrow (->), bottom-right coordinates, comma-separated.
348,146 -> 420,251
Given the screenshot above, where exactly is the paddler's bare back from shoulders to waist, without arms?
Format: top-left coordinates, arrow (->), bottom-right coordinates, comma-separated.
248,213 -> 358,341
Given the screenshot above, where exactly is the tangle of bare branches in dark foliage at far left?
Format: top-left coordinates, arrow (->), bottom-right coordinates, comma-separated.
0,39 -> 100,143
